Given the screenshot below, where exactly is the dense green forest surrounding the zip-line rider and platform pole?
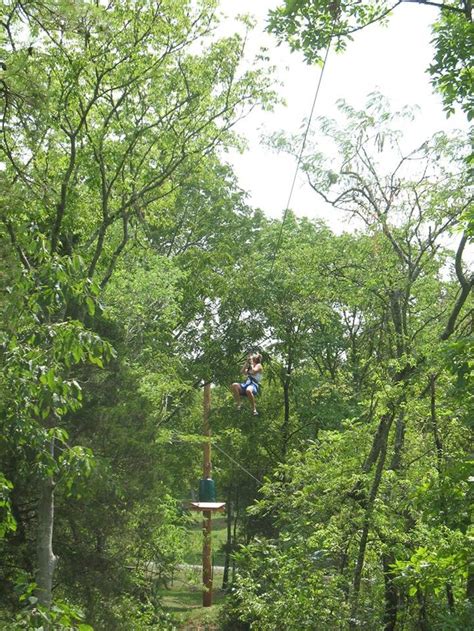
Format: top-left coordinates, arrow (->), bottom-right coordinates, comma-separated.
0,0 -> 474,631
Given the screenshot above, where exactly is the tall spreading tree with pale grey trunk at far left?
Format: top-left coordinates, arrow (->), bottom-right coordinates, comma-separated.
1,0 -> 273,607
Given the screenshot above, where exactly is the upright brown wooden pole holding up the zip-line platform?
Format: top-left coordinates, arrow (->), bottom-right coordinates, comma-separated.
202,383 -> 212,607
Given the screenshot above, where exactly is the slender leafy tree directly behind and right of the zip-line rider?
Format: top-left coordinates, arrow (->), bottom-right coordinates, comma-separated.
260,213 -> 343,461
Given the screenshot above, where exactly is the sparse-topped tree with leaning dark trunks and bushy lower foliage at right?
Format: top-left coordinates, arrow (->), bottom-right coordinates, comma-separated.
223,98 -> 472,631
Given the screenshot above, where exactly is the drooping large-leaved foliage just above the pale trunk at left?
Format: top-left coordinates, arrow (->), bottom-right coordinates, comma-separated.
1,249 -> 113,475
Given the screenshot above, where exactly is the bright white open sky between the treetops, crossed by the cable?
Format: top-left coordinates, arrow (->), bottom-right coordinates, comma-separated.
217,0 -> 467,232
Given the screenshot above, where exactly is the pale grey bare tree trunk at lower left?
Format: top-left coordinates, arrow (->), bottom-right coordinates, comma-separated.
36,477 -> 57,609
